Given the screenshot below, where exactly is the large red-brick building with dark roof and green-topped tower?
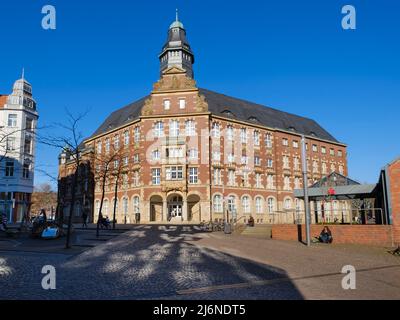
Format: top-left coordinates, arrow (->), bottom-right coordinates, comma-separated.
60,15 -> 347,223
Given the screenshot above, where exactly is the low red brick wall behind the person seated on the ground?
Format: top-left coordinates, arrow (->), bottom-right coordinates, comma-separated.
272,224 -> 398,247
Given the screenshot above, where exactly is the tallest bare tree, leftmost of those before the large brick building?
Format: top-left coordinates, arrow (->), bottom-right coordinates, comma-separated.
38,109 -> 87,249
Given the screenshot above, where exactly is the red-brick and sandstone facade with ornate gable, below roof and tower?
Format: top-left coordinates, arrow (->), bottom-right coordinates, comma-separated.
68,67 -> 347,223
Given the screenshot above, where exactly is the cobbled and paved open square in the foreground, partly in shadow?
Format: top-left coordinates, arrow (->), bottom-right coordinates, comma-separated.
0,226 -> 400,299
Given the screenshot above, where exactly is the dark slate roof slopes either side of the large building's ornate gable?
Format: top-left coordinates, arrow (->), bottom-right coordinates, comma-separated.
88,89 -> 338,142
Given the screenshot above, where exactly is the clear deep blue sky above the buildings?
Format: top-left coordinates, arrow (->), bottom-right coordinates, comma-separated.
0,0 -> 400,184
